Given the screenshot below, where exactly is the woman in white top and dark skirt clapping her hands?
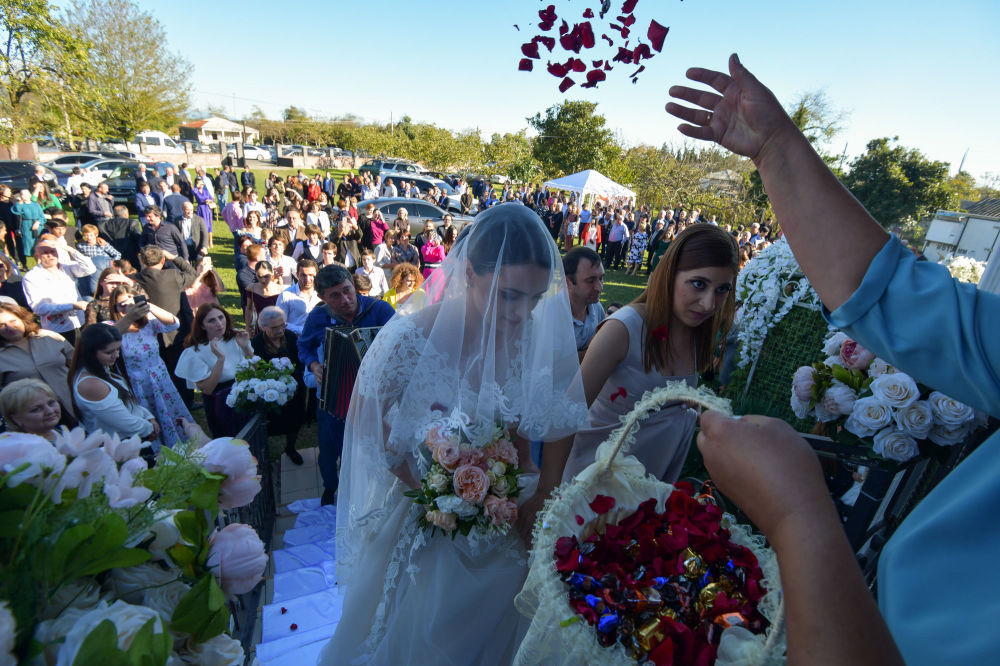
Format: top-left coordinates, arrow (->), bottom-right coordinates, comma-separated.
174,303 -> 253,437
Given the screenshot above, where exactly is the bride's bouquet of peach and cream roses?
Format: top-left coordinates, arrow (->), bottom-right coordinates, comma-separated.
404,425 -> 524,539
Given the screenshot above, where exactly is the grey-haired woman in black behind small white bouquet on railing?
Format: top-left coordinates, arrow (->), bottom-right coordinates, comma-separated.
250,305 -> 306,465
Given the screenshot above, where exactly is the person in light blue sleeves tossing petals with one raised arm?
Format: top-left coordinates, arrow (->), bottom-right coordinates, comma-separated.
667,55 -> 1000,665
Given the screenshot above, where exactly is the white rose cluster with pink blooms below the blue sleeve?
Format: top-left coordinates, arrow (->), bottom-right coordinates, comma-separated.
791,331 -> 976,462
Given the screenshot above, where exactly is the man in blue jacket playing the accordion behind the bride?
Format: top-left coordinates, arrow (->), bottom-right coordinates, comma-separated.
299,264 -> 396,504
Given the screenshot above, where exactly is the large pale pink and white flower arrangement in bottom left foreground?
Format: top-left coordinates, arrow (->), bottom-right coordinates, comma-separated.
0,428 -> 267,666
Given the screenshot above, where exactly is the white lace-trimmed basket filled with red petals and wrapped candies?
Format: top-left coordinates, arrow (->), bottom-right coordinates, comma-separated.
514,382 -> 785,666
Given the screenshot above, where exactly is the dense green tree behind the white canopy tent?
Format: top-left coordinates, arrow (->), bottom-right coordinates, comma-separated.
527,100 -> 621,176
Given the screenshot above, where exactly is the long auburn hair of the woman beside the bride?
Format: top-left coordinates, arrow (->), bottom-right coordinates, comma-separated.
632,224 -> 739,372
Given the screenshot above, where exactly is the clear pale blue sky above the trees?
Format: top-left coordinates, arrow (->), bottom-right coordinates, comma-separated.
139,0 -> 1000,178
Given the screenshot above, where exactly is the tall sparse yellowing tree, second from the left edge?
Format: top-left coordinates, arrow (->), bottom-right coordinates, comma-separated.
62,0 -> 192,139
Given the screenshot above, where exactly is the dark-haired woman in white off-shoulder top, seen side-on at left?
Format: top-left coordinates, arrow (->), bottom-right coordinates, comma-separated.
69,324 -> 160,440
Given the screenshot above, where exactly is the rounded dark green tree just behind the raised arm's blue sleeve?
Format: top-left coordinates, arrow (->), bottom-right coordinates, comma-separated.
843,137 -> 952,228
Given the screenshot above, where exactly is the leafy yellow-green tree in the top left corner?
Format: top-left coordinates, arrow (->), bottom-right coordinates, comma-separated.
0,0 -> 88,145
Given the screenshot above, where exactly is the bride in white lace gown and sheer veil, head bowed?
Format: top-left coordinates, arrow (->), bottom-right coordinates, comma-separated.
319,203 -> 587,665
